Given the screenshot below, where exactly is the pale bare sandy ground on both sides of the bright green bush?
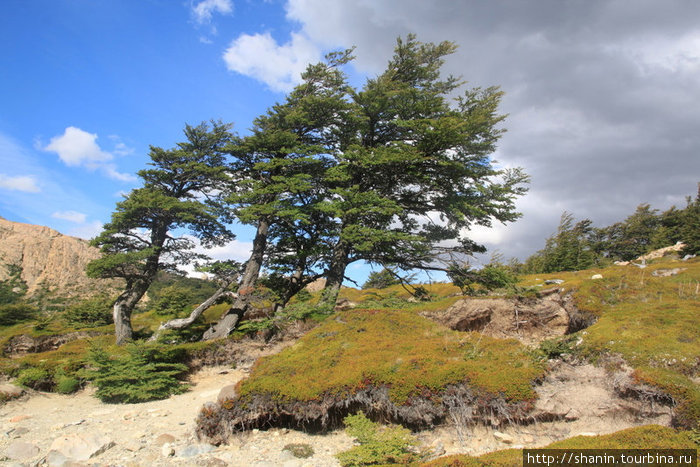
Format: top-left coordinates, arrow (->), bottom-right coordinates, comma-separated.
0,365 -> 670,467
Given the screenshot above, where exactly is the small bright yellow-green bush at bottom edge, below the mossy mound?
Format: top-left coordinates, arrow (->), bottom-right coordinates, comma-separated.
336,412 -> 422,467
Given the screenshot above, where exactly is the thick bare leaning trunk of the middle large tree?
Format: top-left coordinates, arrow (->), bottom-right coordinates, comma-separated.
202,219 -> 270,341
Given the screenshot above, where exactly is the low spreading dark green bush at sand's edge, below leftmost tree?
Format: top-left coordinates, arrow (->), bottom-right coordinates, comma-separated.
89,344 -> 188,403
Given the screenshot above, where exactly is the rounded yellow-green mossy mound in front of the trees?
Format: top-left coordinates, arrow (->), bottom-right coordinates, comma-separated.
238,310 -> 544,410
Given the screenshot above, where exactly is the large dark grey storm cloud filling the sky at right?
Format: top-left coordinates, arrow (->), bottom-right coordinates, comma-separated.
288,0 -> 700,258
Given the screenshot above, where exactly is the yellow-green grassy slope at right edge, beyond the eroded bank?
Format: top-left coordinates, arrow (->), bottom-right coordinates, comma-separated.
524,258 -> 700,428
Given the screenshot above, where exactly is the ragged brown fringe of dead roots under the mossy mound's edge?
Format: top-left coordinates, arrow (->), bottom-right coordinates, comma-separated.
196,384 -> 532,444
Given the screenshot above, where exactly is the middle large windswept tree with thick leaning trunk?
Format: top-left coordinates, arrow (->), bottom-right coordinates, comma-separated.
204,50 -> 352,339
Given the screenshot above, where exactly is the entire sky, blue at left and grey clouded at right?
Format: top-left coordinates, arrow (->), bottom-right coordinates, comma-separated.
0,0 -> 700,282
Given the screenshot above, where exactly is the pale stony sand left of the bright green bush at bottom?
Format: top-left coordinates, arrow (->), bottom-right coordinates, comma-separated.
0,367 -> 352,467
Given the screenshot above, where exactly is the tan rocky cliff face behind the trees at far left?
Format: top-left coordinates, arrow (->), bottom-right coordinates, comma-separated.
0,217 -> 118,297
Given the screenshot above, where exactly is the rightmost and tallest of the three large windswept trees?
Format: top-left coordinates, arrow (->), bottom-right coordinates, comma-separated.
316,35 -> 527,307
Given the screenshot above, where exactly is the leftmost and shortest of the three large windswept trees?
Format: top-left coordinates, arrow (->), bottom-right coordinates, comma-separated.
87,123 -> 233,345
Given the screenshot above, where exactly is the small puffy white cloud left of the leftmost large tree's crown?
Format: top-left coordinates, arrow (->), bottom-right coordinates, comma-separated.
44,126 -> 112,167
